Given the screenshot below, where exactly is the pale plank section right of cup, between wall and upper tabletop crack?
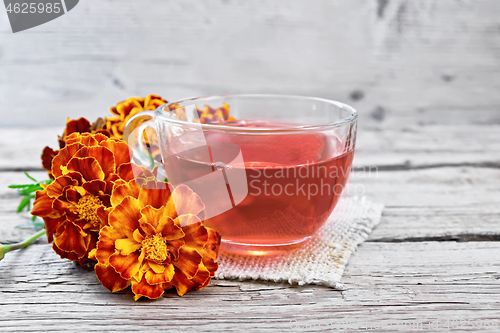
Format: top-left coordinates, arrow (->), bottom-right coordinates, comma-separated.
353,125 -> 500,169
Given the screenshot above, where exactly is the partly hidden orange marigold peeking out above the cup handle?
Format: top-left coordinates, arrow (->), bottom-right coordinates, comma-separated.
106,95 -> 168,139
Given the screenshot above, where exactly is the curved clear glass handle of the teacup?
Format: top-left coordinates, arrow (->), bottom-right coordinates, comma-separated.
123,111 -> 161,171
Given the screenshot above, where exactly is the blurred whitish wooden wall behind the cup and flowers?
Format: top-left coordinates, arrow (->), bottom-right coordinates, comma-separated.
0,0 -> 500,128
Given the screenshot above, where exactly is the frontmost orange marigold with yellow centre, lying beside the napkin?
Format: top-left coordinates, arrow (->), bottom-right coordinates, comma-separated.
95,180 -> 220,300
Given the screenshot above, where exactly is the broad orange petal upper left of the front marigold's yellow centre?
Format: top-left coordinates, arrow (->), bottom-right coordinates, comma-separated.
108,197 -> 142,236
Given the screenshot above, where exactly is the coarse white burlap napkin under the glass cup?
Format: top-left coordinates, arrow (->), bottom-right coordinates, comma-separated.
215,197 -> 383,290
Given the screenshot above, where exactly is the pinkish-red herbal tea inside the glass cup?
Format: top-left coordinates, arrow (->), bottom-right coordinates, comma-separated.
165,122 -> 353,254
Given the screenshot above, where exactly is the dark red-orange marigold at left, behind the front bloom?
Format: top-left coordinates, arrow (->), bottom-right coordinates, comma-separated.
31,132 -> 153,264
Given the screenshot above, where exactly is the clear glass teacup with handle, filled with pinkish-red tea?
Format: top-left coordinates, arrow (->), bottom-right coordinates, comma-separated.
124,95 -> 357,255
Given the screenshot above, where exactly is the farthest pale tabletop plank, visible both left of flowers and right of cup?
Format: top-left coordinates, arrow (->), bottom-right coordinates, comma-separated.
0,125 -> 500,170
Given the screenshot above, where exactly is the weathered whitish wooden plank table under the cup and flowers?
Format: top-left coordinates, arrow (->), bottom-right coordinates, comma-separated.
0,118 -> 500,332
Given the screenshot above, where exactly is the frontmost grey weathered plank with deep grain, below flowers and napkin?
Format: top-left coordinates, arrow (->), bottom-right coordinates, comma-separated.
0,242 -> 500,332
